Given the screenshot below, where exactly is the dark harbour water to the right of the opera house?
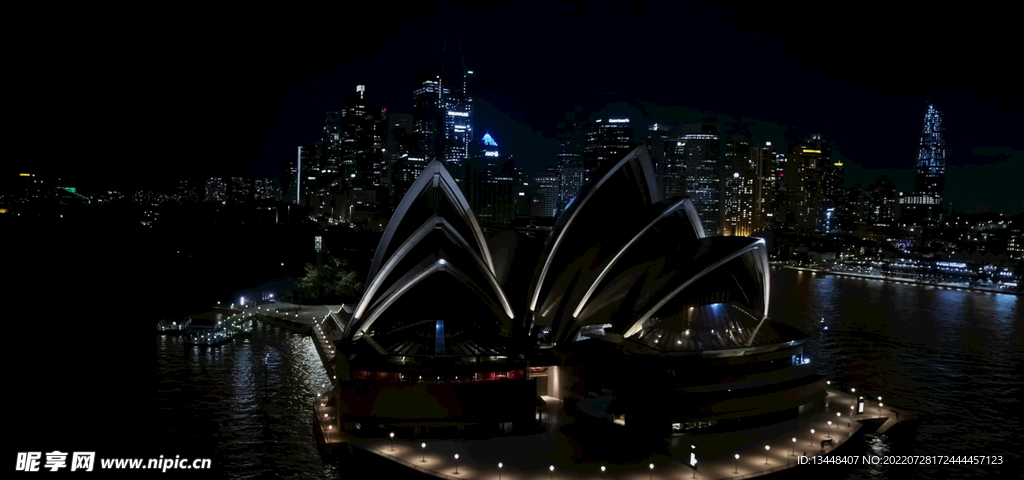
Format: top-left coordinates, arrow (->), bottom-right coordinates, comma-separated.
771,269 -> 1024,479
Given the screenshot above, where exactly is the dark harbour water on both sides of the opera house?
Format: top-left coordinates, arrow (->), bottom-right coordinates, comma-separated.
154,269 -> 1024,479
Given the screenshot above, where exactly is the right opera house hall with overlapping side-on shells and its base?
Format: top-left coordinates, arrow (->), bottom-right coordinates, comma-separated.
527,146 -> 825,436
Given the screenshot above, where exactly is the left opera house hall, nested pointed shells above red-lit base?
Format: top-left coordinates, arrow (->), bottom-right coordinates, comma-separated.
333,162 -> 538,432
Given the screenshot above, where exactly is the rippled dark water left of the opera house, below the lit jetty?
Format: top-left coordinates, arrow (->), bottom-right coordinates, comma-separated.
157,324 -> 339,479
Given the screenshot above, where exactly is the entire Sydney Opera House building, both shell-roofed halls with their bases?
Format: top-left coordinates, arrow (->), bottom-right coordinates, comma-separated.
326,146 -> 825,437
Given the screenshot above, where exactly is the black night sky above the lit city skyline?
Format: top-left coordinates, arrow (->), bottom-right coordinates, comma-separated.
12,1 -> 1024,213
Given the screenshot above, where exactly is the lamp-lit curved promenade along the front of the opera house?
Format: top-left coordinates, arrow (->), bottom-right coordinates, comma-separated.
315,384 -> 908,480
